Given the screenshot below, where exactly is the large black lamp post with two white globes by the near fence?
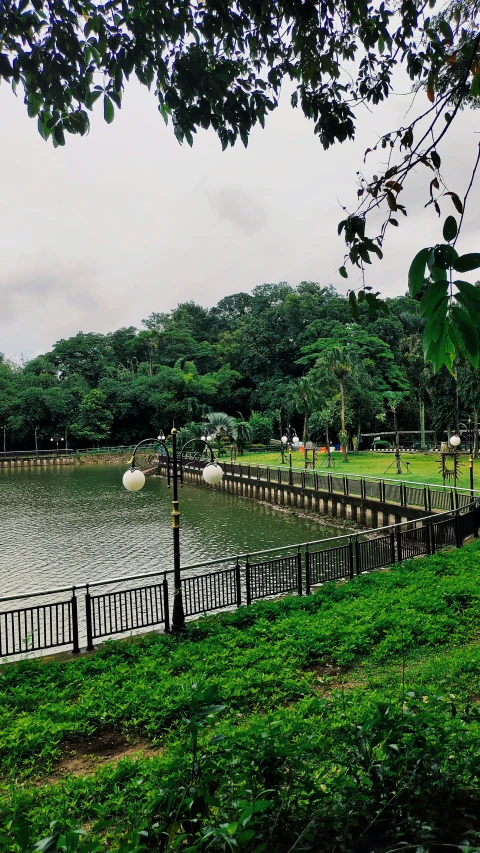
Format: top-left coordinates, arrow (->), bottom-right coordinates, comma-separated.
123,427 -> 223,631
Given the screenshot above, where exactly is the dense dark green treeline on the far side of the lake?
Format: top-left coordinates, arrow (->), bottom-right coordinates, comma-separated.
0,282 -> 480,449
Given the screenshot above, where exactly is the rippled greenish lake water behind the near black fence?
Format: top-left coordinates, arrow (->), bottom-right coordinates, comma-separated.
0,465 -> 345,596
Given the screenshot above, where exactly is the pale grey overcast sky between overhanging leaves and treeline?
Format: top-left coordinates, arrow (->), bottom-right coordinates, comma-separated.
0,75 -> 480,358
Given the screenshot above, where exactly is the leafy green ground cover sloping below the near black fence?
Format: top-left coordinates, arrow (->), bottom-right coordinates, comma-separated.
0,542 -> 480,853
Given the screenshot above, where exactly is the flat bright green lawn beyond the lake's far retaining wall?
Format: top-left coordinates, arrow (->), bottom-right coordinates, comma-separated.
237,451 -> 480,489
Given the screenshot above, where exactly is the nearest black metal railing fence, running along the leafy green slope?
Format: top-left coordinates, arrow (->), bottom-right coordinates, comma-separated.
0,498 -> 480,659
